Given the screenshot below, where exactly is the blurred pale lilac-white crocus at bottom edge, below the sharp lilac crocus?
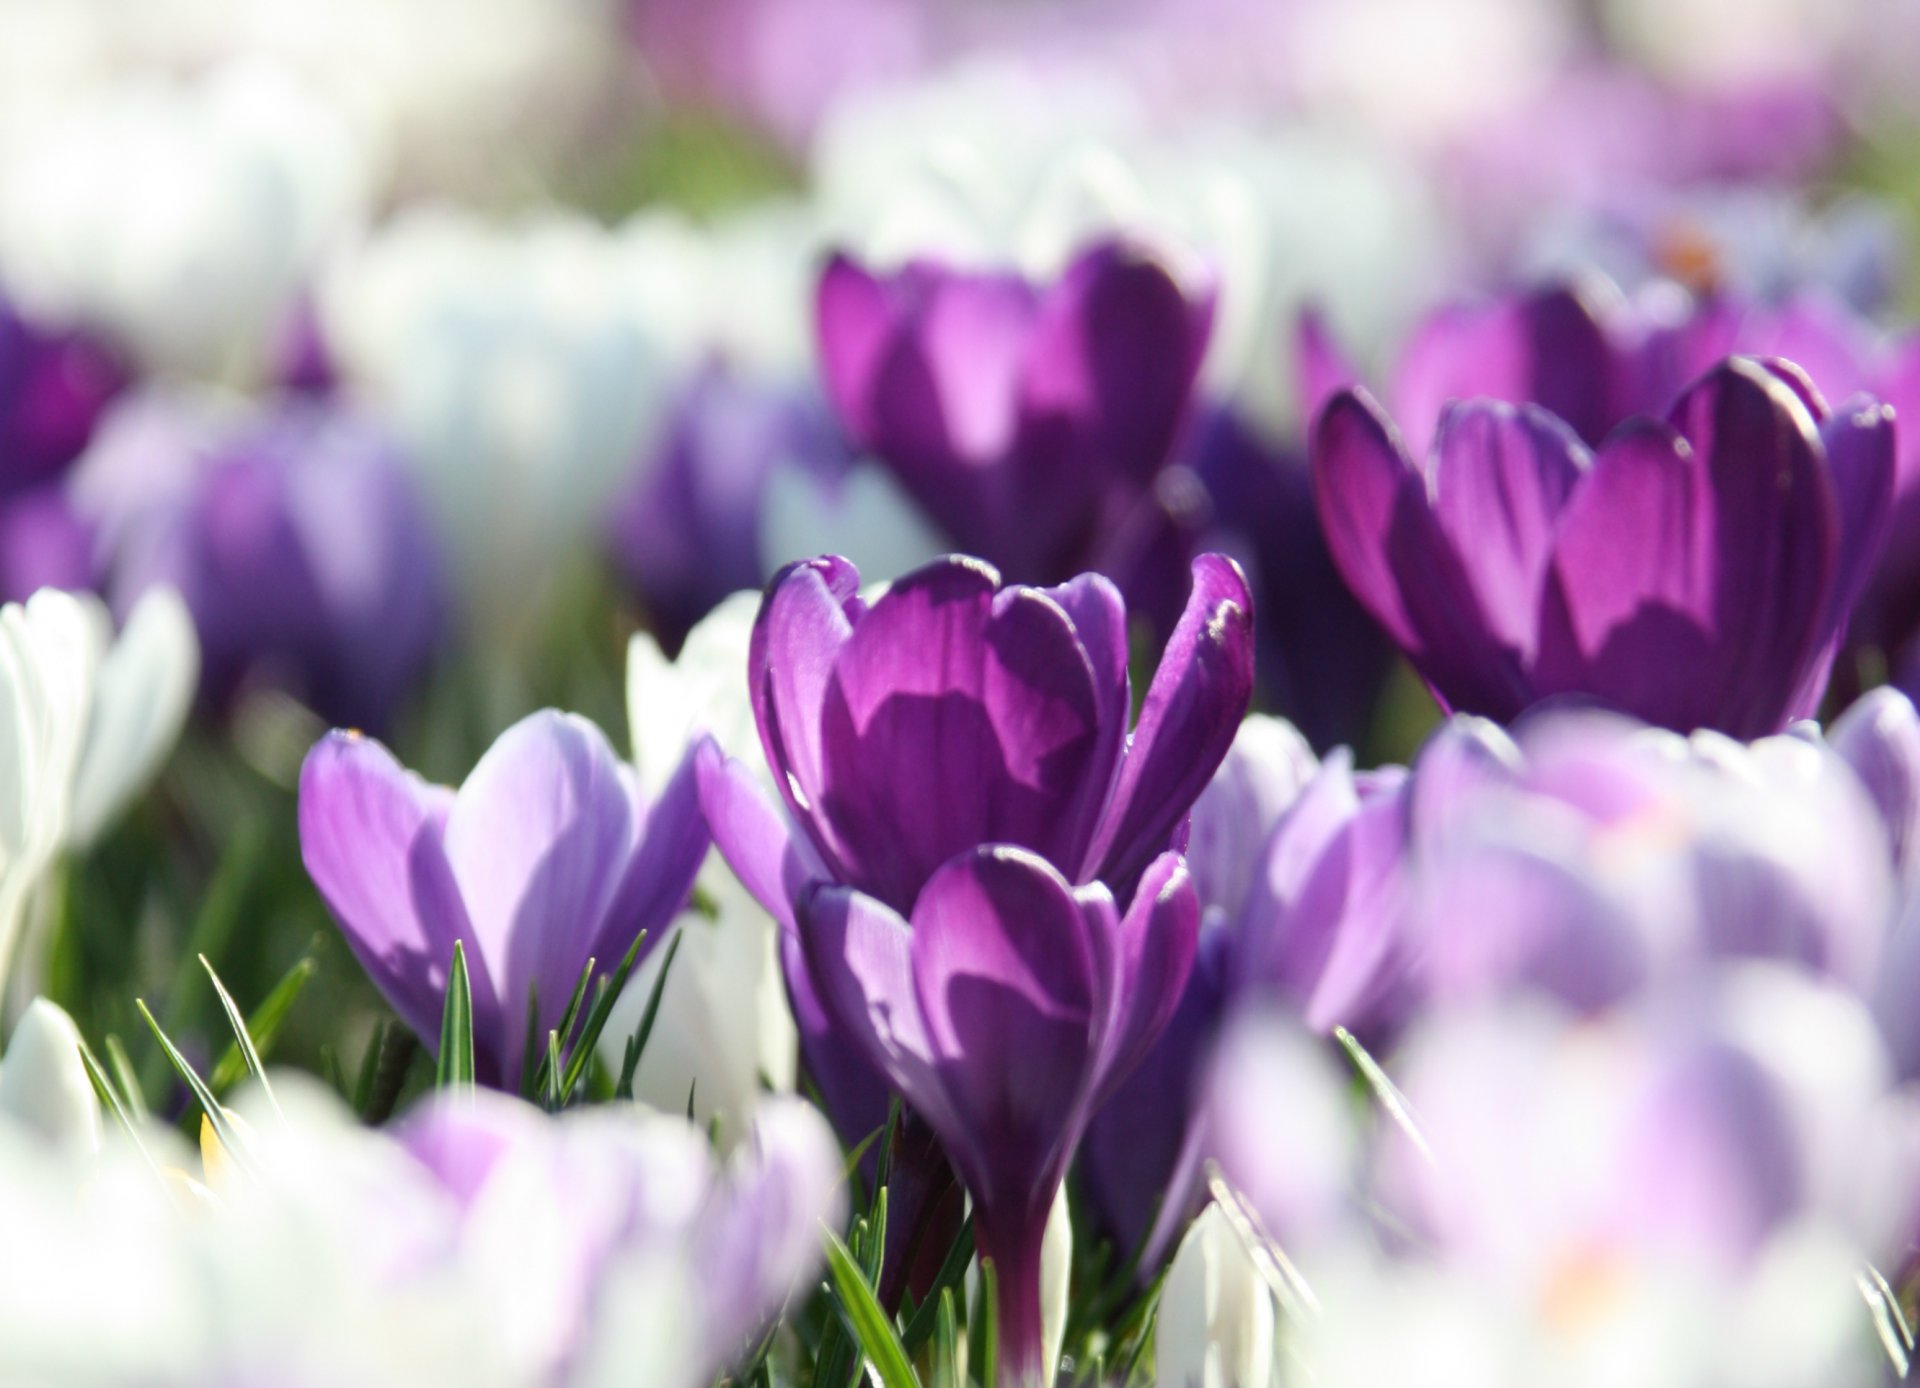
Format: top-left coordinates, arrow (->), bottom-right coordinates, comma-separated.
396,1094 -> 845,1388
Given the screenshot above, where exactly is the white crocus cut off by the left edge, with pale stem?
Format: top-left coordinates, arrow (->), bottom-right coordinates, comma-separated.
0,587 -> 200,1002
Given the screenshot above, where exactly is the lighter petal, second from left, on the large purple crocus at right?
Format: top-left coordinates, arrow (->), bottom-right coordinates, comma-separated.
1434,401 -> 1590,657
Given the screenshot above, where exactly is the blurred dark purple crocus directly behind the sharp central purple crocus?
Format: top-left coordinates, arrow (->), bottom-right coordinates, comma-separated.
816,244 -> 1213,598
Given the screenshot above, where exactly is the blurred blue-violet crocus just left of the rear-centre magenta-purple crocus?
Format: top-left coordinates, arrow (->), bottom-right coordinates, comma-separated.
611,363 -> 852,645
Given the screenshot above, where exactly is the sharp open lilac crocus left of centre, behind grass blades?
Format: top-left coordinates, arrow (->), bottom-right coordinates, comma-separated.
300,710 -> 708,1089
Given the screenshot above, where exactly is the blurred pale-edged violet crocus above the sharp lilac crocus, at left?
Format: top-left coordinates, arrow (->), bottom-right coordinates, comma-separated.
71,395 -> 444,730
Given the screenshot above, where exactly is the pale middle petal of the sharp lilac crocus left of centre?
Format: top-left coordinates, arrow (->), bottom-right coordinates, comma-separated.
445,710 -> 634,1085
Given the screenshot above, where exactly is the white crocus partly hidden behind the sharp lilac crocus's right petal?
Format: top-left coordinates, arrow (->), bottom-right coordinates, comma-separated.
601,591 -> 799,1142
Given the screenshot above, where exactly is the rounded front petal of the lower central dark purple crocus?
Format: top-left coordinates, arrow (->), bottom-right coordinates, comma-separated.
912,847 -> 1106,1223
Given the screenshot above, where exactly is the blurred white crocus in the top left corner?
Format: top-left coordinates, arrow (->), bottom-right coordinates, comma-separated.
0,63 -> 367,380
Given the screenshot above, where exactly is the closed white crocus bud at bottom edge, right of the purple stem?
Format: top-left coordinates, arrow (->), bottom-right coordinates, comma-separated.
1154,1206 -> 1277,1388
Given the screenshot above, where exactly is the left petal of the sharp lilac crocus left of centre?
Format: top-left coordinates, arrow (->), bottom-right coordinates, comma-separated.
300,731 -> 486,1046
